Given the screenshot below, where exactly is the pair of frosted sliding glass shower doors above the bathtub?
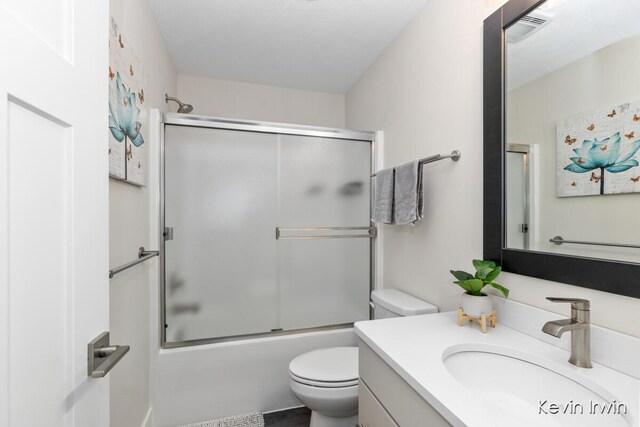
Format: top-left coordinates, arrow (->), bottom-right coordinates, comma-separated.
163,125 -> 371,345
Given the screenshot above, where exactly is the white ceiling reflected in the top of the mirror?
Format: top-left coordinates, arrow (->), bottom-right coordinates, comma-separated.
506,0 -> 640,90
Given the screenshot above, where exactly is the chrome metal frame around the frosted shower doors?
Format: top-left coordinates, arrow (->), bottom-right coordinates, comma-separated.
158,113 -> 376,349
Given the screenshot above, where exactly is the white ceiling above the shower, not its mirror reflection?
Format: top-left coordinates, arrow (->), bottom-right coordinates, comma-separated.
149,0 -> 427,93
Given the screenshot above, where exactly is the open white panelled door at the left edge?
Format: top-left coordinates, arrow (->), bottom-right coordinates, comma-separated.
0,0 -> 110,427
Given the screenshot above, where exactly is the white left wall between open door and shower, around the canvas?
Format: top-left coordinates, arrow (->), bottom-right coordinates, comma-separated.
104,0 -> 176,427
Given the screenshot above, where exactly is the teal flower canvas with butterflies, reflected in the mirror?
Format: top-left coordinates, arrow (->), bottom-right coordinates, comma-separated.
556,101 -> 640,197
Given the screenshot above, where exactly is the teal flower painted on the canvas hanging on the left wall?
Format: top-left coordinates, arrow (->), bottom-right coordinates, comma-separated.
109,72 -> 144,147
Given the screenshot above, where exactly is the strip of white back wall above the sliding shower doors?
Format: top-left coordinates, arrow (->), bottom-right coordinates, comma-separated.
178,75 -> 345,128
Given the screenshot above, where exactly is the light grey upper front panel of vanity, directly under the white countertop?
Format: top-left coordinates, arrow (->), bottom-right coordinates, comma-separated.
358,341 -> 451,427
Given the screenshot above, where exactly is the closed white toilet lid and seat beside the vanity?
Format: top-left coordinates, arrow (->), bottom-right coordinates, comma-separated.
289,347 -> 358,387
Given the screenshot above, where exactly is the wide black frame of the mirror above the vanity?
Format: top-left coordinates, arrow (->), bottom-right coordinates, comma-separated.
483,0 -> 640,298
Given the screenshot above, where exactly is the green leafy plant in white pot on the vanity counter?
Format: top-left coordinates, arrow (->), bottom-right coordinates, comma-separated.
451,259 -> 509,317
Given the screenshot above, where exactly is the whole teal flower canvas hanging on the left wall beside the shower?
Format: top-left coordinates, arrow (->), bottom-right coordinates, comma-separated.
109,18 -> 149,186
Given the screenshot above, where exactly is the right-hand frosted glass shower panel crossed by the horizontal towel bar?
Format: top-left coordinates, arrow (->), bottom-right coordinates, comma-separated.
278,135 -> 371,330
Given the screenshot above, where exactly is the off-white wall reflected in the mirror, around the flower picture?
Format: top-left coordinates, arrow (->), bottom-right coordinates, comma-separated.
506,36 -> 640,262
